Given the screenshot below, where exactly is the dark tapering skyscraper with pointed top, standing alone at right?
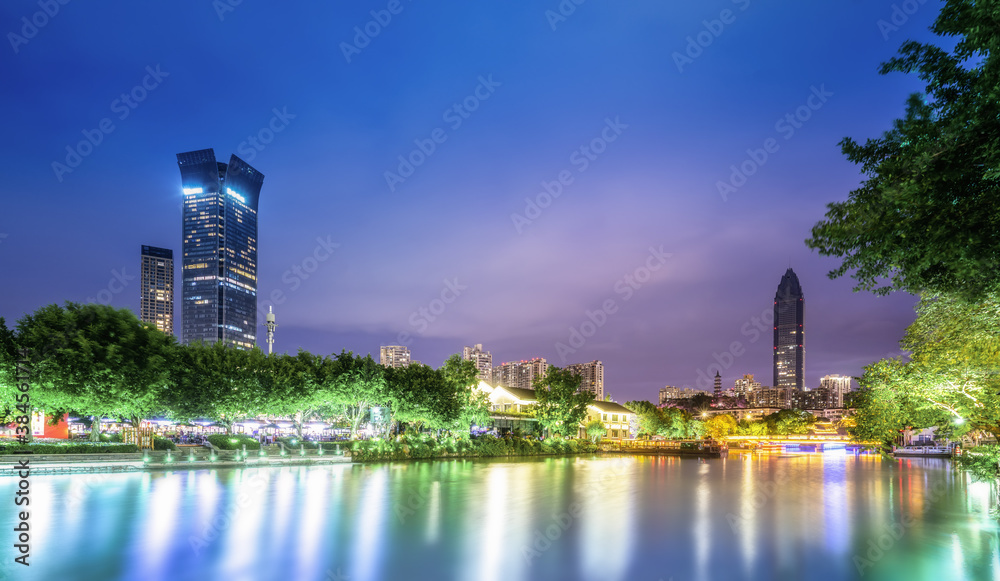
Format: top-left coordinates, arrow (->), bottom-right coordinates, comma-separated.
774,268 -> 805,391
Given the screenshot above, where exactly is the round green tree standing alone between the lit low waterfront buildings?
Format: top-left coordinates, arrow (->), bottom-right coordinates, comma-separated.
534,367 -> 594,436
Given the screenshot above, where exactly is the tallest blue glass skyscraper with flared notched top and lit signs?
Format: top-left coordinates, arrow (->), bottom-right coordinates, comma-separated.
177,149 -> 264,349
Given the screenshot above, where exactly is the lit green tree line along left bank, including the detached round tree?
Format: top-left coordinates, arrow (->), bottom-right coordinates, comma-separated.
0,302 -> 593,440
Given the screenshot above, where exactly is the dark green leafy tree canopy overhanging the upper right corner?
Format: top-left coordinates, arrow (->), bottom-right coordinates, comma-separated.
806,0 -> 1000,300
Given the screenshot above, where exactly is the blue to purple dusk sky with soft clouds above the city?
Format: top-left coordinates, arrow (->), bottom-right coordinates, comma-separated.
0,0 -> 940,401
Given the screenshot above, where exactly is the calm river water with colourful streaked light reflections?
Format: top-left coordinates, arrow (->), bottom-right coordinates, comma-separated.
0,453 -> 1000,581
